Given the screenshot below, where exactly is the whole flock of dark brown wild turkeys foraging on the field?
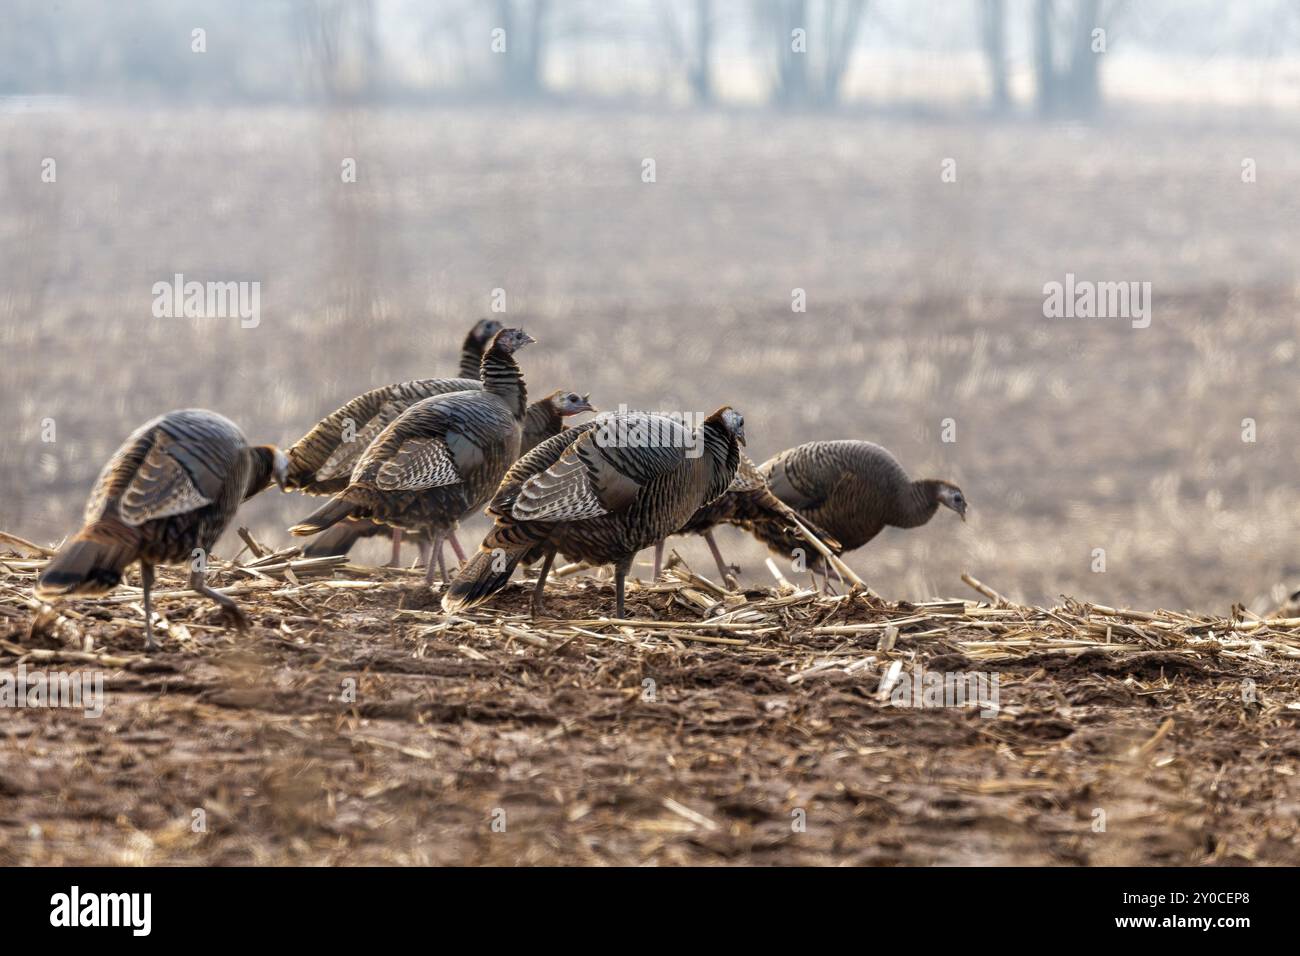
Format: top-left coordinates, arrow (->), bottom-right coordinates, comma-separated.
36,319 -> 966,648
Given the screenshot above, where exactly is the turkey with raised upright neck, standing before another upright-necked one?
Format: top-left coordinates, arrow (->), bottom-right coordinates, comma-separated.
290,329 -> 533,583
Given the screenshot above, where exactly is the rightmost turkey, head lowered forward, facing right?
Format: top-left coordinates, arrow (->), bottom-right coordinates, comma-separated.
744,441 -> 966,567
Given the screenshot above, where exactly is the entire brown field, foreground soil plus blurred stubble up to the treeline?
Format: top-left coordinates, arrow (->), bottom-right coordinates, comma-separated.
0,111 -> 1300,864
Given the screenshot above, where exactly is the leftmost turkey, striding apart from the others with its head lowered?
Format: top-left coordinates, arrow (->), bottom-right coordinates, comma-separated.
36,408 -> 289,650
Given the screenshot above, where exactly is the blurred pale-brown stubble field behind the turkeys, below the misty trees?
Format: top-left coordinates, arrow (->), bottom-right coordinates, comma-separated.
0,111 -> 1300,614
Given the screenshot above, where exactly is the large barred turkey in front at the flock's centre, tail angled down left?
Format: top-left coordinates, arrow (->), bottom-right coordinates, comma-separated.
442,407 -> 745,618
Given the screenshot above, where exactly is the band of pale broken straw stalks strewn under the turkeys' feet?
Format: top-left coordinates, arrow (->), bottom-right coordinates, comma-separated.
0,529 -> 1300,680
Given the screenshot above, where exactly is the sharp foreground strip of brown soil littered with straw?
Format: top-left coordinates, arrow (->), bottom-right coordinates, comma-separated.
0,535 -> 1300,864
